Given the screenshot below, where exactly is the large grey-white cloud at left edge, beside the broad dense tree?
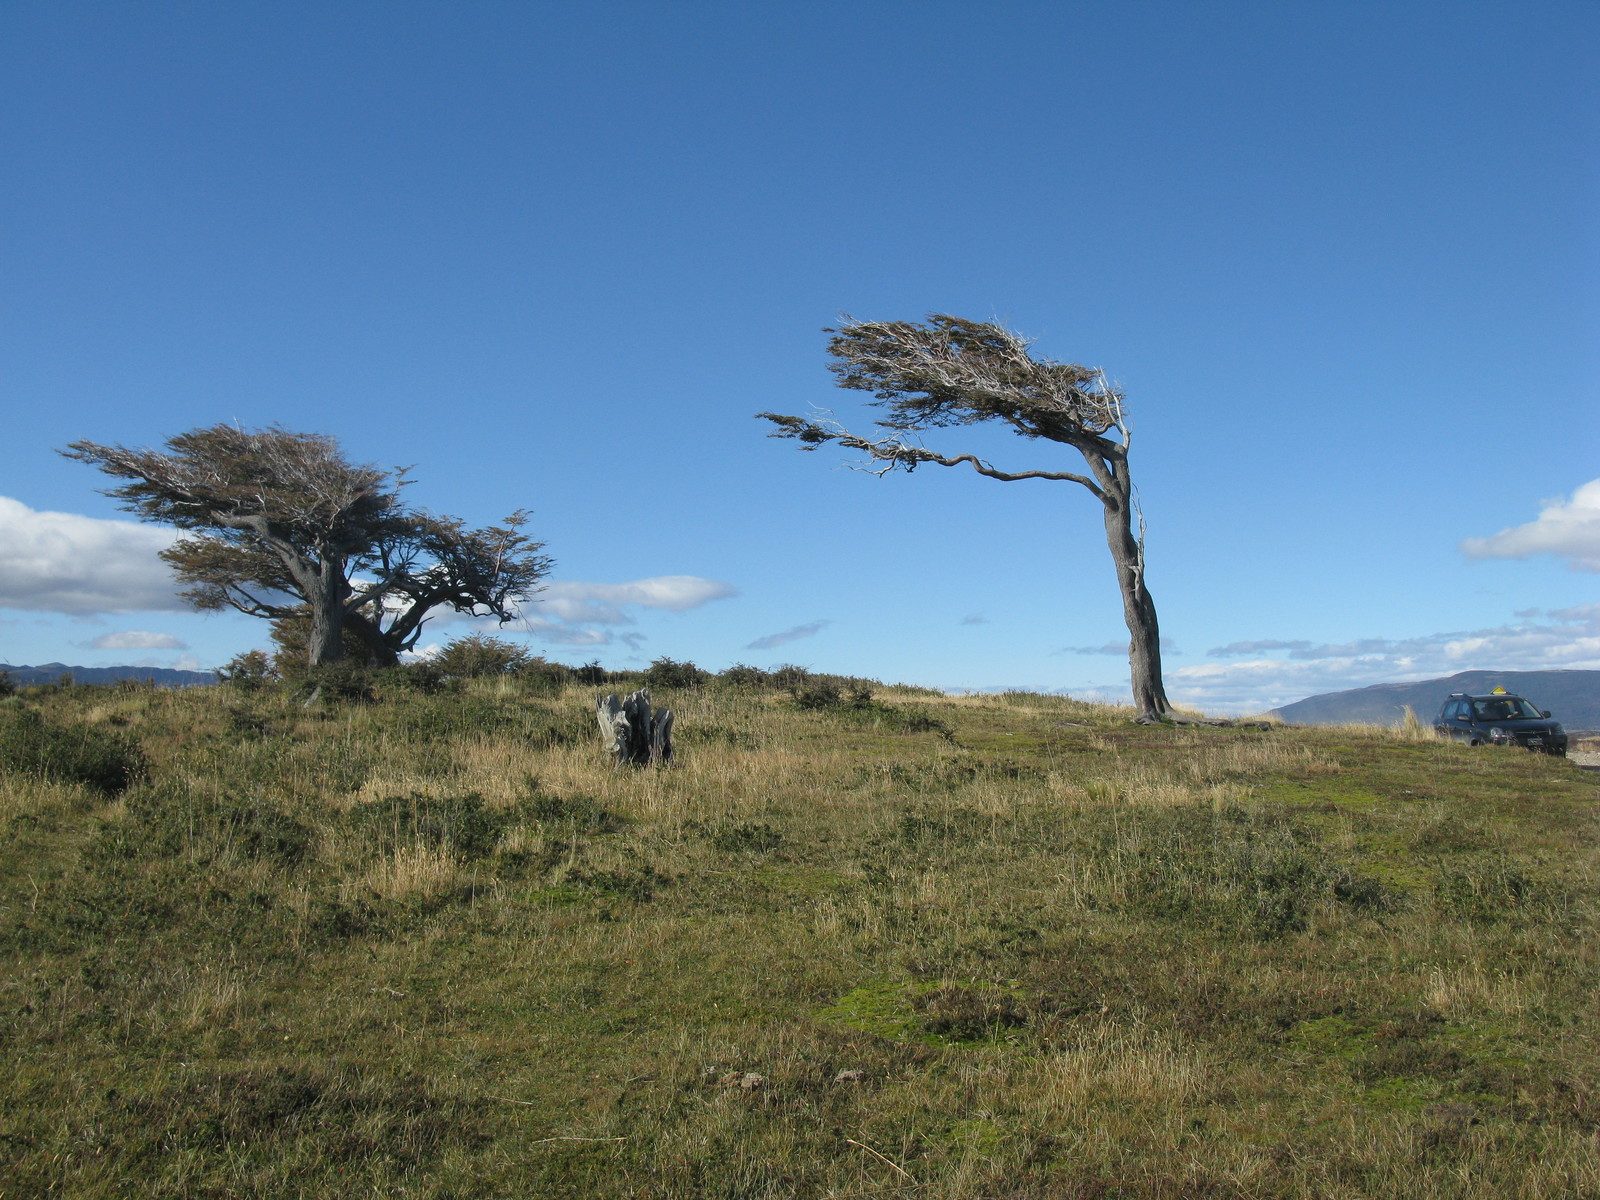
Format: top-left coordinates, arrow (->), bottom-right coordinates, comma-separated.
0,496 -> 187,616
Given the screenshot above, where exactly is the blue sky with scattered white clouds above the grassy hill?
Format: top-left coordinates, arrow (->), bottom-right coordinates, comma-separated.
0,0 -> 1600,712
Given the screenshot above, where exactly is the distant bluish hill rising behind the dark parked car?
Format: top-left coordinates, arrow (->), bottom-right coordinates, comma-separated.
1269,670 -> 1600,733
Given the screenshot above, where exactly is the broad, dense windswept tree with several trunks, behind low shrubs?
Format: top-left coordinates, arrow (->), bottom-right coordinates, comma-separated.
62,424 -> 550,666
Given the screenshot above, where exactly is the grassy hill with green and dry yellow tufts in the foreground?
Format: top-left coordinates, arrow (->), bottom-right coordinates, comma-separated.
0,680 -> 1600,1200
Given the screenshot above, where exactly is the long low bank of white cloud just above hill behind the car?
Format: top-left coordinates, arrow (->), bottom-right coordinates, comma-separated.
1166,605 -> 1600,712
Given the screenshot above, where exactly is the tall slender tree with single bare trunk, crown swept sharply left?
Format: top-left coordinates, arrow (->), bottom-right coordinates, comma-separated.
757,314 -> 1173,722
